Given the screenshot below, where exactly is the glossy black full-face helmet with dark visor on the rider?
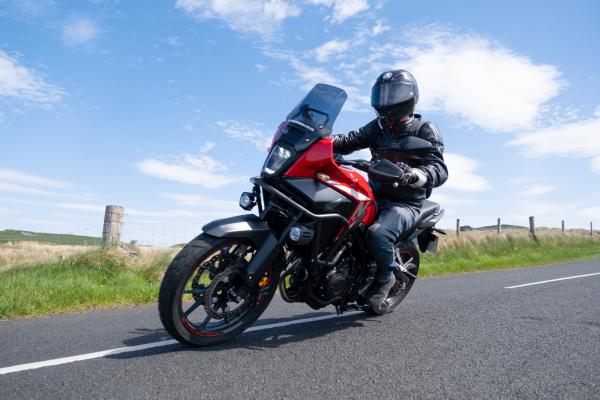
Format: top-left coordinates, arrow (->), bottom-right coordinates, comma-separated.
371,69 -> 419,123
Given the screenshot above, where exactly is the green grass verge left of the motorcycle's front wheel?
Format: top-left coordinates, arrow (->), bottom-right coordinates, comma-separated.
0,250 -> 172,318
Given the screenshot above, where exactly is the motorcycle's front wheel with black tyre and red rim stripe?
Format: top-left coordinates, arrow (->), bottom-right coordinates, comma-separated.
158,234 -> 279,346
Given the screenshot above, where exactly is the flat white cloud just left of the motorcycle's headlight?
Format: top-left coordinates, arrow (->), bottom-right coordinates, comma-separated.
136,154 -> 247,189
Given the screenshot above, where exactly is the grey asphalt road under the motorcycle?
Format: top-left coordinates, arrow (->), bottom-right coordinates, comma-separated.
0,260 -> 600,399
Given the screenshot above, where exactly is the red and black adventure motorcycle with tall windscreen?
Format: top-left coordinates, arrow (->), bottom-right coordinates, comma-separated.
158,84 -> 445,346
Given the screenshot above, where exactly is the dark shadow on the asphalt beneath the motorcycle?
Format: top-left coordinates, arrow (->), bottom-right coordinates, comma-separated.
107,312 -> 376,359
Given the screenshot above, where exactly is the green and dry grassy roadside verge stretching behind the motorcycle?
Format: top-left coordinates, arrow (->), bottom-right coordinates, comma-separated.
0,229 -> 600,318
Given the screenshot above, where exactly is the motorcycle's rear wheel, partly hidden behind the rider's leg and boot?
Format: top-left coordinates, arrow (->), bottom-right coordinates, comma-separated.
363,243 -> 419,315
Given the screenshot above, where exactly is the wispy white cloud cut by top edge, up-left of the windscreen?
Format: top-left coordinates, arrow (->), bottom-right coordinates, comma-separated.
176,0 -> 300,40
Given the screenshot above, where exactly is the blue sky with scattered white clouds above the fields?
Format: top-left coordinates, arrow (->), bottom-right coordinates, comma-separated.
0,0 -> 600,244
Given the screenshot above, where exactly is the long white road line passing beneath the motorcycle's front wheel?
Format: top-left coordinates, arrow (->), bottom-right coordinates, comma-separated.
0,311 -> 362,375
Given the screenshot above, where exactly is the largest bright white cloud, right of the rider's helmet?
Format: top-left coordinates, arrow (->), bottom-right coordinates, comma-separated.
396,27 -> 562,132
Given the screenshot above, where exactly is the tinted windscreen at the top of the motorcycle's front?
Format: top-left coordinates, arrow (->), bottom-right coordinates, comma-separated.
286,83 -> 348,130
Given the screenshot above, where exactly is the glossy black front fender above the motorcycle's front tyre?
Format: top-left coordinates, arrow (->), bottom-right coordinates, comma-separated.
202,214 -> 277,248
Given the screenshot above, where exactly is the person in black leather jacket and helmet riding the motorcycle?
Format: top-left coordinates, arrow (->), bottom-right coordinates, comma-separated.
333,69 -> 448,312
